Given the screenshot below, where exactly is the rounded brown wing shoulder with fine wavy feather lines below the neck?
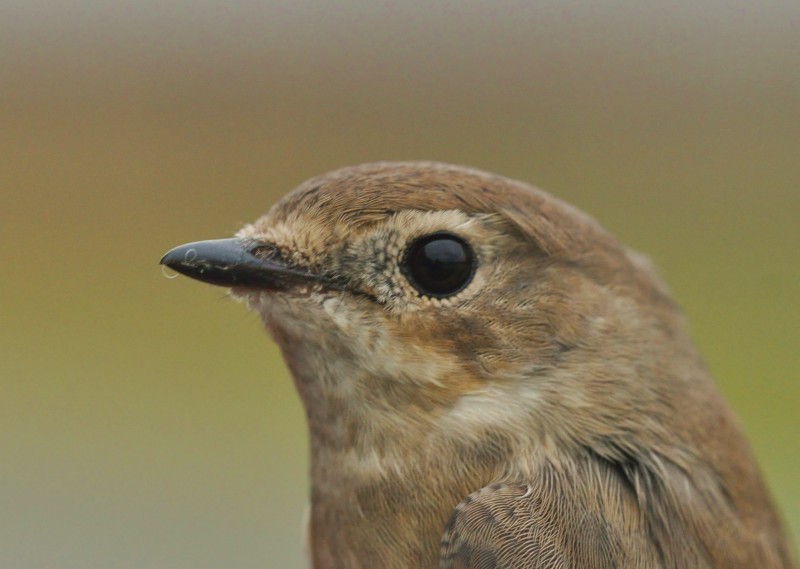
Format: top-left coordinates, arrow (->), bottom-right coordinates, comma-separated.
440,460 -> 662,569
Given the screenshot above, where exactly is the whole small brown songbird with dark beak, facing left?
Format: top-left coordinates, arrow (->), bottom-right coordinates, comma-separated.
161,162 -> 795,569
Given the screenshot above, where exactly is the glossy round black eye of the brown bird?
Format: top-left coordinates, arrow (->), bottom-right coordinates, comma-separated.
402,233 -> 475,298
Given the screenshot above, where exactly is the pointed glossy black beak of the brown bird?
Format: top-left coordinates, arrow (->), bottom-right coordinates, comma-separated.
161,239 -> 319,291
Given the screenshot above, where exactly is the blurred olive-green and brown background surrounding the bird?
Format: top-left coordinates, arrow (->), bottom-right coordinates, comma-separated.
0,0 -> 800,569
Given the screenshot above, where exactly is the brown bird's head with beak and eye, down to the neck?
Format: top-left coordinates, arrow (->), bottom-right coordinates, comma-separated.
162,163 -> 696,466
